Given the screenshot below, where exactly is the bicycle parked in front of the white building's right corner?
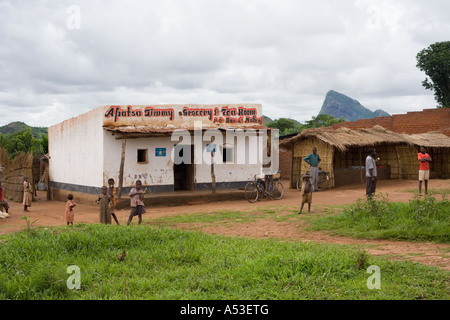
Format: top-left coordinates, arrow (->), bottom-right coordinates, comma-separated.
244,171 -> 284,203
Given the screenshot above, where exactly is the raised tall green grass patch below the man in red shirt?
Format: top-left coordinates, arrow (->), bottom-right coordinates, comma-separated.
310,194 -> 450,243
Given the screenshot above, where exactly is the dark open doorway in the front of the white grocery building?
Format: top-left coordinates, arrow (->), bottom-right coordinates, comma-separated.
173,145 -> 195,191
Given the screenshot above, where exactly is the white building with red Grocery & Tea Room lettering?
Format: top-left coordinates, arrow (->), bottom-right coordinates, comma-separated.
48,104 -> 278,200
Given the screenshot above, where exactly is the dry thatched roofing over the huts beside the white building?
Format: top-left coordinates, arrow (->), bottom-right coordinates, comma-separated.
280,125 -> 450,152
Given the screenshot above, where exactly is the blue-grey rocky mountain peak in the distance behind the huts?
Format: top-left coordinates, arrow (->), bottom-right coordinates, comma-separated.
319,90 -> 390,121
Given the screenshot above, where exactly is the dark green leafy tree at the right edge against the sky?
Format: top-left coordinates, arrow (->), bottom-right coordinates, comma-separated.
416,41 -> 450,108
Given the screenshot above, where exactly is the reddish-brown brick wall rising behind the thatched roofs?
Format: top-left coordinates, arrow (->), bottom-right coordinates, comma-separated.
333,108 -> 450,136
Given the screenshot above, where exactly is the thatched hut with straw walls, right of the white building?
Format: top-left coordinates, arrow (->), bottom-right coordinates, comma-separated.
280,126 -> 450,187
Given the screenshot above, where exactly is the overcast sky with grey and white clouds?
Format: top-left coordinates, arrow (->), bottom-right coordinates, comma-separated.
0,0 -> 450,126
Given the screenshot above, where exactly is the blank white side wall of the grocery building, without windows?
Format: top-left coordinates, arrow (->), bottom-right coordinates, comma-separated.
48,108 -> 104,193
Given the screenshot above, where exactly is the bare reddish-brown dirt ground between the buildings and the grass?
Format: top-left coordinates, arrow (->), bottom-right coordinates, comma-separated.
0,180 -> 450,271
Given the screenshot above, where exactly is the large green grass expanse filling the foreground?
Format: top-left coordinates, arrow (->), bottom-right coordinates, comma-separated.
0,224 -> 449,300
